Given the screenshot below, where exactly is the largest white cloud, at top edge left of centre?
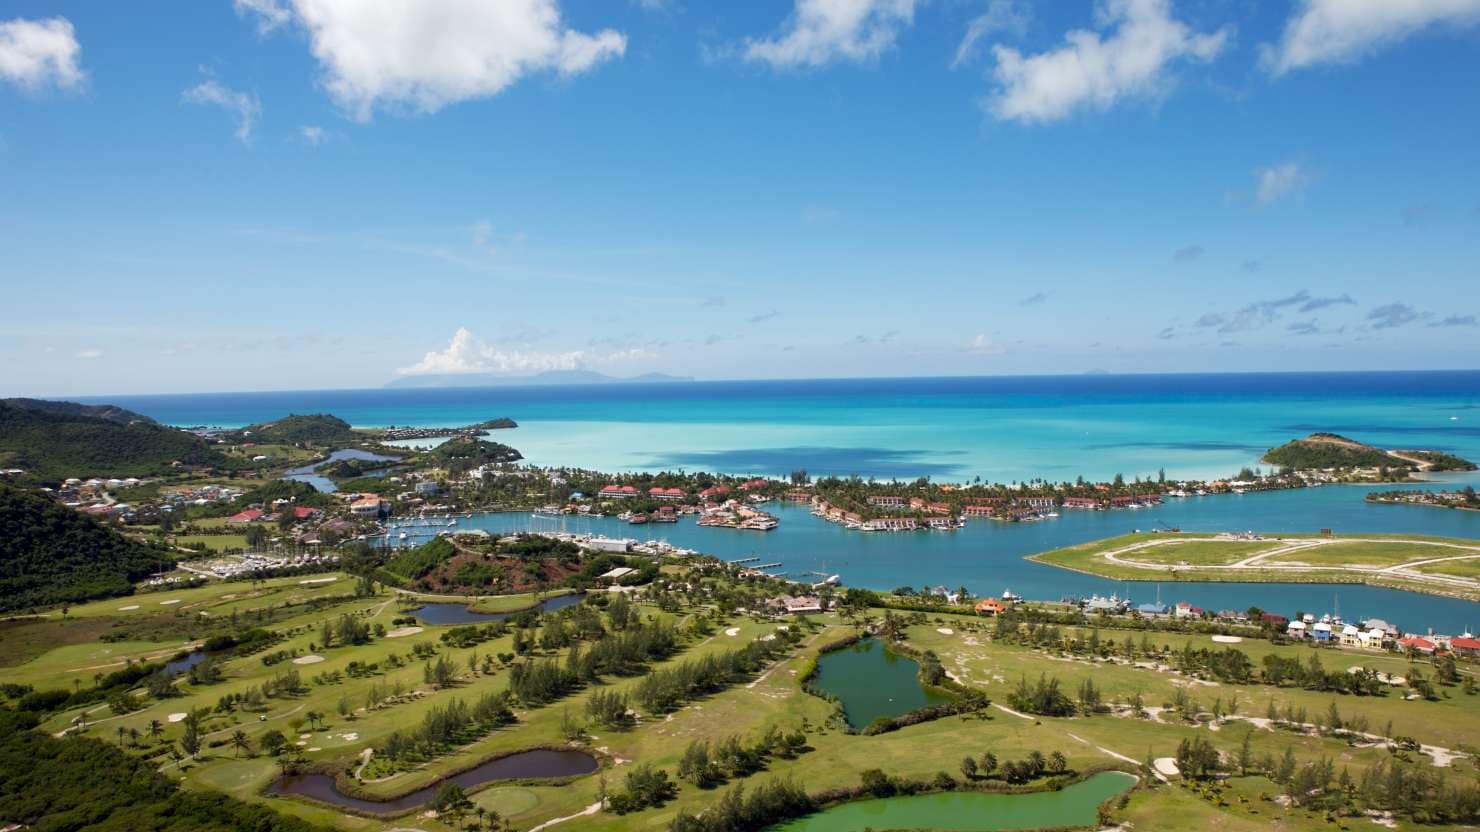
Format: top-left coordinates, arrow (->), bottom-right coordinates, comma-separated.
237,0 -> 628,121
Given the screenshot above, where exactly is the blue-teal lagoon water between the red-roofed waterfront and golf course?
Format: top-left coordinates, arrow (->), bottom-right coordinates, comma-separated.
438,477 -> 1480,634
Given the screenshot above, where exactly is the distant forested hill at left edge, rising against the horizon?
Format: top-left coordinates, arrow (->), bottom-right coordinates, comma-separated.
0,403 -> 229,483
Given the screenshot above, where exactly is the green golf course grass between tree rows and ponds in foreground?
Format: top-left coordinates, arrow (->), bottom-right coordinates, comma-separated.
11,568 -> 1480,832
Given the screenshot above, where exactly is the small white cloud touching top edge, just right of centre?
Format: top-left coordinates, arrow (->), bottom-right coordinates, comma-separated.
743,0 -> 915,70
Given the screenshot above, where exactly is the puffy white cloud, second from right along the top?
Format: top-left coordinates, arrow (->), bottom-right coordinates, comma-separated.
987,0 -> 1233,123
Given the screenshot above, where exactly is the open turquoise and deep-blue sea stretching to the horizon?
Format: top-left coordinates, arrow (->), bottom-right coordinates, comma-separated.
89,372 -> 1480,481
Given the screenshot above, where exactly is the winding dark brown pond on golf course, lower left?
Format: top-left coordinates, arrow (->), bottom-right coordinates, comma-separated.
268,748 -> 599,814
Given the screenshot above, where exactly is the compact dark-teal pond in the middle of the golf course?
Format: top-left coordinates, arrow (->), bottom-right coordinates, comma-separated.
811,638 -> 950,730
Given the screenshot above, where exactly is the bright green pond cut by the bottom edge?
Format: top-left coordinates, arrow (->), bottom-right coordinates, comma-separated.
768,771 -> 1135,832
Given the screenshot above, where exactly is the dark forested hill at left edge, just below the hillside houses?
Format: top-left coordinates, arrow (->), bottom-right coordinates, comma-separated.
0,484 -> 173,611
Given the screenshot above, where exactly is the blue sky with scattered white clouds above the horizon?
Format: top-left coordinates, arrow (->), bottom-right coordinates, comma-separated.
0,0 -> 1480,395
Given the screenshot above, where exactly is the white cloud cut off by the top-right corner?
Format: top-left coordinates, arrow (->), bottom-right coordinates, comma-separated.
1262,0 -> 1480,76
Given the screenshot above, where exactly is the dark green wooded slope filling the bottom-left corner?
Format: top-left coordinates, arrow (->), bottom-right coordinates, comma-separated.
0,704 -> 323,832
